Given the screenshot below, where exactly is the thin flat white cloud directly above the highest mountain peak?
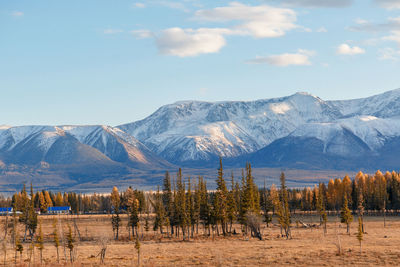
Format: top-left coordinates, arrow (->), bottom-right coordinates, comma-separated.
247,49 -> 315,67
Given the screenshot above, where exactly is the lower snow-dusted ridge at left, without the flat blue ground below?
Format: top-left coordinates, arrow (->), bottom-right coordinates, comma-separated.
0,125 -> 170,168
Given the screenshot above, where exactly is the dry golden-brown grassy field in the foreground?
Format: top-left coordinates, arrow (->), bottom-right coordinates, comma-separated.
0,215 -> 400,266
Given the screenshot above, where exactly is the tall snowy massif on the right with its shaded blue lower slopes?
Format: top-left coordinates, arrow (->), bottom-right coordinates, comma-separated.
118,89 -> 400,171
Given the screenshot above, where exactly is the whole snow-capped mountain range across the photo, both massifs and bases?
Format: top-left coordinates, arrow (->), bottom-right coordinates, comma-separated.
0,89 -> 400,191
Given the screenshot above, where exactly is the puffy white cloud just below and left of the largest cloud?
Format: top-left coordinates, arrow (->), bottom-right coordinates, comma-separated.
156,28 -> 226,57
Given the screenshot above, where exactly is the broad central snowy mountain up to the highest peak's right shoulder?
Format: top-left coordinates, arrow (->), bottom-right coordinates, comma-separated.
119,93 -> 341,162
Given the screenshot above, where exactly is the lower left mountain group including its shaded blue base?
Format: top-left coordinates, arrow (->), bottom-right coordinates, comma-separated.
0,126 -> 172,186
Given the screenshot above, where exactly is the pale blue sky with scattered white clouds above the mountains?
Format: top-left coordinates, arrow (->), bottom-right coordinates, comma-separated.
0,0 -> 400,126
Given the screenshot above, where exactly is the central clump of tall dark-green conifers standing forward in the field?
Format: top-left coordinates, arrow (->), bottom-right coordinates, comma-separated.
110,160 -> 290,240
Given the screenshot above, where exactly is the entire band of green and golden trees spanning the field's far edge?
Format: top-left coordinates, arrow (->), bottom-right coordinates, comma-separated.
0,163 -> 400,239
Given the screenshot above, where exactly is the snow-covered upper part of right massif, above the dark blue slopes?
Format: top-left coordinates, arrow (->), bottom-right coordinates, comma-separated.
118,90 -> 400,166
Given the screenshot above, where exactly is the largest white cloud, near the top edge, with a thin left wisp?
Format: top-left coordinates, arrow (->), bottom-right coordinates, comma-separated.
195,2 -> 299,38
